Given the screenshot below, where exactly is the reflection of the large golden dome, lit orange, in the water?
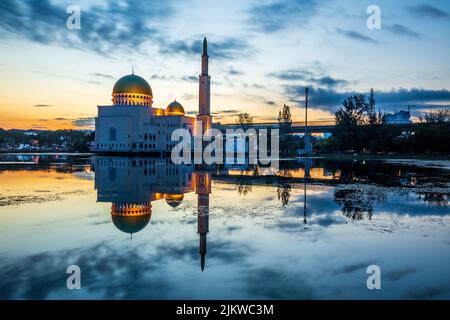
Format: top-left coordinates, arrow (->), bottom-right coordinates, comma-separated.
111,203 -> 152,234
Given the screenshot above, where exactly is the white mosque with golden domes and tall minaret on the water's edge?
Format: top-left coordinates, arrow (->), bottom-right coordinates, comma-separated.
93,38 -> 212,155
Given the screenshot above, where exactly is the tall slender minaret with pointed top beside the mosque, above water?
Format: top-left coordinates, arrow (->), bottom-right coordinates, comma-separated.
197,38 -> 212,134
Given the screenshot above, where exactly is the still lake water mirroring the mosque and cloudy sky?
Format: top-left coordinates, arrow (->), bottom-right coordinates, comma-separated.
0,155 -> 450,299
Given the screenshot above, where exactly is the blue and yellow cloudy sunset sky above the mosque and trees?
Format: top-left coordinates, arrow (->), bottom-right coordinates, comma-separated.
0,0 -> 450,129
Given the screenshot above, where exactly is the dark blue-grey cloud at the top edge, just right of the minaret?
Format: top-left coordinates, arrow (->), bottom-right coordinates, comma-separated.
248,0 -> 318,32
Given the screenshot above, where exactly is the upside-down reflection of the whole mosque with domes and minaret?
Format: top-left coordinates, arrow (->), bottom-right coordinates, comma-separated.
94,157 -> 211,270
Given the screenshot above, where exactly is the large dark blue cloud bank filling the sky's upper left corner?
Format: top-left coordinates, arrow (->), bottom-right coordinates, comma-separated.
0,0 -> 174,55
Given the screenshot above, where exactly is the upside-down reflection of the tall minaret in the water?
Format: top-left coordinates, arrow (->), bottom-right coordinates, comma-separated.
196,172 -> 211,271
